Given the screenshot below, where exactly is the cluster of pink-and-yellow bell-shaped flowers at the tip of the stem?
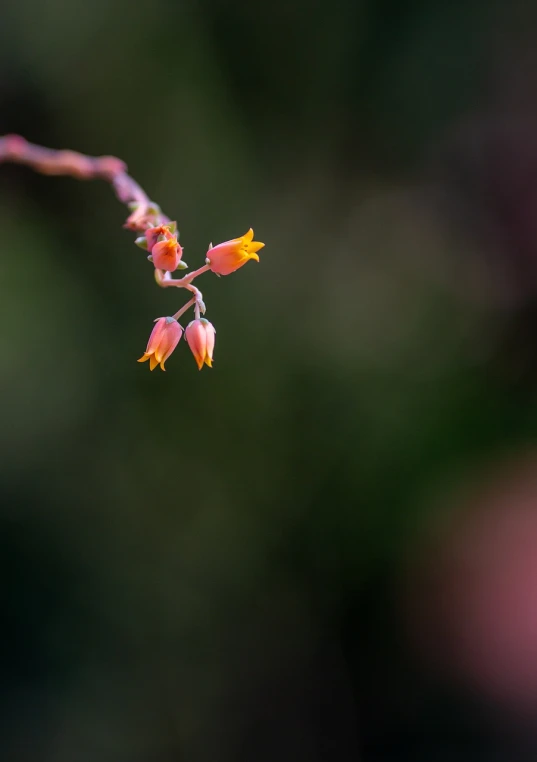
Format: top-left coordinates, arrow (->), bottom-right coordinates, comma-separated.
130,204 -> 265,370
